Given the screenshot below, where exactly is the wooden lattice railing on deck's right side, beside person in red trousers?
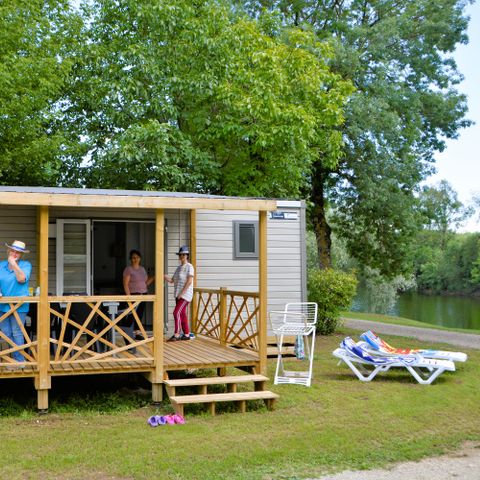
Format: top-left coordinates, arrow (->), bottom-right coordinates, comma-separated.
192,288 -> 260,352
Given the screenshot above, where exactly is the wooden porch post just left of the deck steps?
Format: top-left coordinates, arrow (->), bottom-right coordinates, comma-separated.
151,209 -> 165,403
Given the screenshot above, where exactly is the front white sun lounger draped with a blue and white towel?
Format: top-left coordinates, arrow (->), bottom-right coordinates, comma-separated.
333,337 -> 455,385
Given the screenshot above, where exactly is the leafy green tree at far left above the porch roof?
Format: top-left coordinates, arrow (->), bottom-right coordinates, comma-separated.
0,0 -> 77,185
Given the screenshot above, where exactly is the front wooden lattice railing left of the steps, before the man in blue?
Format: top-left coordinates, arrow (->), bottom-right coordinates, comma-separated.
0,295 -> 155,370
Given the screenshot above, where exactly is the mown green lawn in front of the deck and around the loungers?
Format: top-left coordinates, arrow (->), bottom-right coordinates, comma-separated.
0,329 -> 480,480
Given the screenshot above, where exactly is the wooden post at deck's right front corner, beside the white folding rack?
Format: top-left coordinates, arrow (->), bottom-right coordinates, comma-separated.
258,211 -> 268,375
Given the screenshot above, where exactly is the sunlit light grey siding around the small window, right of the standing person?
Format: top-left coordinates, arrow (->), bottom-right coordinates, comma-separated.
196,201 -> 306,310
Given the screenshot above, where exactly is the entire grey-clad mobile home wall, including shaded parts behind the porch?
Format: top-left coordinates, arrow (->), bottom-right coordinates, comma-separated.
0,201 -> 306,332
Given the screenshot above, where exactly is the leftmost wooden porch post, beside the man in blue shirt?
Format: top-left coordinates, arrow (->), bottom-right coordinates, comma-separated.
35,206 -> 52,411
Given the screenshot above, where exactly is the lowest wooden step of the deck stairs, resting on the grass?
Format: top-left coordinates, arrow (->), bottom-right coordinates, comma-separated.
170,390 -> 278,415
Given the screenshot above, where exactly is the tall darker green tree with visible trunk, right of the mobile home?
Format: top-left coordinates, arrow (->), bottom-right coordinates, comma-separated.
241,0 -> 470,275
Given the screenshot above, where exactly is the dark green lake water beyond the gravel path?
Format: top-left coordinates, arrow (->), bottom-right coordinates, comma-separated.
351,292 -> 480,330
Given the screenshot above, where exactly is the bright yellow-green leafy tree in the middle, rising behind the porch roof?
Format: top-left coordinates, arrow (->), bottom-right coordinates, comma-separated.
62,0 -> 352,196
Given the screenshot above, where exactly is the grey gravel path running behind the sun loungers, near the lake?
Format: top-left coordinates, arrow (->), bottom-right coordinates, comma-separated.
344,318 -> 480,349
